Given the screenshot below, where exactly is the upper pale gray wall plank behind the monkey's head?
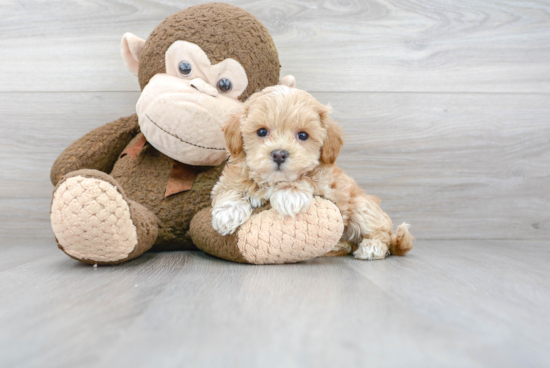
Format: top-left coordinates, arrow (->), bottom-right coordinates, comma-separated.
0,0 -> 550,93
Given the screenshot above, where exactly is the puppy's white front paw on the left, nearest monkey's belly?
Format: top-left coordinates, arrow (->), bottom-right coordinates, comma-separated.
212,201 -> 252,235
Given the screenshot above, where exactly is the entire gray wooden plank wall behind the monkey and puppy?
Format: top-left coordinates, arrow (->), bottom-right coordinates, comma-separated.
0,0 -> 550,239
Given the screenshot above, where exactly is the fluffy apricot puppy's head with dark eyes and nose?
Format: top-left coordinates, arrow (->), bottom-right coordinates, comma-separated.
224,86 -> 342,183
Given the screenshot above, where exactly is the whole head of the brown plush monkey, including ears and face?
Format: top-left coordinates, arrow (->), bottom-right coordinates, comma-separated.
121,3 -> 295,166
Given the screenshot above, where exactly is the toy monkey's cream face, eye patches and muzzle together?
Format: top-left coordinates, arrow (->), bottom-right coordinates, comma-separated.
136,41 -> 248,165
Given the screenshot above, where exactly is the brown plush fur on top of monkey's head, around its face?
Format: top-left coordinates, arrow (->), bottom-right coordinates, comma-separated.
139,3 -> 281,101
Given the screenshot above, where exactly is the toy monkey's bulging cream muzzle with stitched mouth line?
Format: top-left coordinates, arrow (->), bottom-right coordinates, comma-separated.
136,74 -> 237,166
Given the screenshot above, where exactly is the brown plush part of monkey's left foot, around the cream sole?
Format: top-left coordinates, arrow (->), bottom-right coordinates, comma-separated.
54,170 -> 158,265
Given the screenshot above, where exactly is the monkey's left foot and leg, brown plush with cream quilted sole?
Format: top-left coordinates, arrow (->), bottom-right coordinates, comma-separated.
50,170 -> 159,264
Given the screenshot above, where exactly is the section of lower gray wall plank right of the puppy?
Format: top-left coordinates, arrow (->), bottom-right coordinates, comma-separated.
315,93 -> 550,239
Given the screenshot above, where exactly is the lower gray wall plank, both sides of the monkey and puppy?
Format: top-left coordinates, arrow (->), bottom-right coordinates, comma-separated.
0,92 -> 550,239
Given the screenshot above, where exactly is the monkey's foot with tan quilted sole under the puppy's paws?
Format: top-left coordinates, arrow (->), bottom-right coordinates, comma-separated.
190,198 -> 344,264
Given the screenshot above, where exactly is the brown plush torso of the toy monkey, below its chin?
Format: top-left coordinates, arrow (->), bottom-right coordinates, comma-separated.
111,137 -> 225,250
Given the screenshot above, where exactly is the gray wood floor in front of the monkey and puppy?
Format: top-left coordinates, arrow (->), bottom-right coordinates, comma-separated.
0,239 -> 550,367
